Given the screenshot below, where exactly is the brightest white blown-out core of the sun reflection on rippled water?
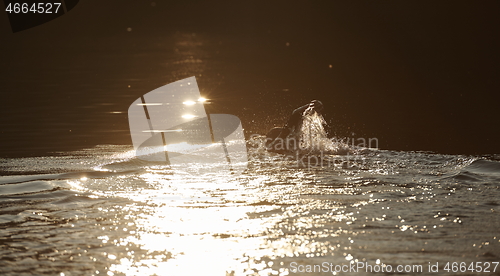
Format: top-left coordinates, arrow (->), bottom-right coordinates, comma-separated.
104,173 -> 275,275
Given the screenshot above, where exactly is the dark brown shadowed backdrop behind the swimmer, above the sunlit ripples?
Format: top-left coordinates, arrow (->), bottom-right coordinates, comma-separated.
0,0 -> 500,157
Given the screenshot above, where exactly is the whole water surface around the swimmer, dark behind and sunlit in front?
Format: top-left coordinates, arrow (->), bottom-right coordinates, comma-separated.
0,1 -> 500,275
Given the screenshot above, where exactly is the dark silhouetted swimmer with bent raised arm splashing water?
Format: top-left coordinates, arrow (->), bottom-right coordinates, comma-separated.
266,100 -> 323,153
